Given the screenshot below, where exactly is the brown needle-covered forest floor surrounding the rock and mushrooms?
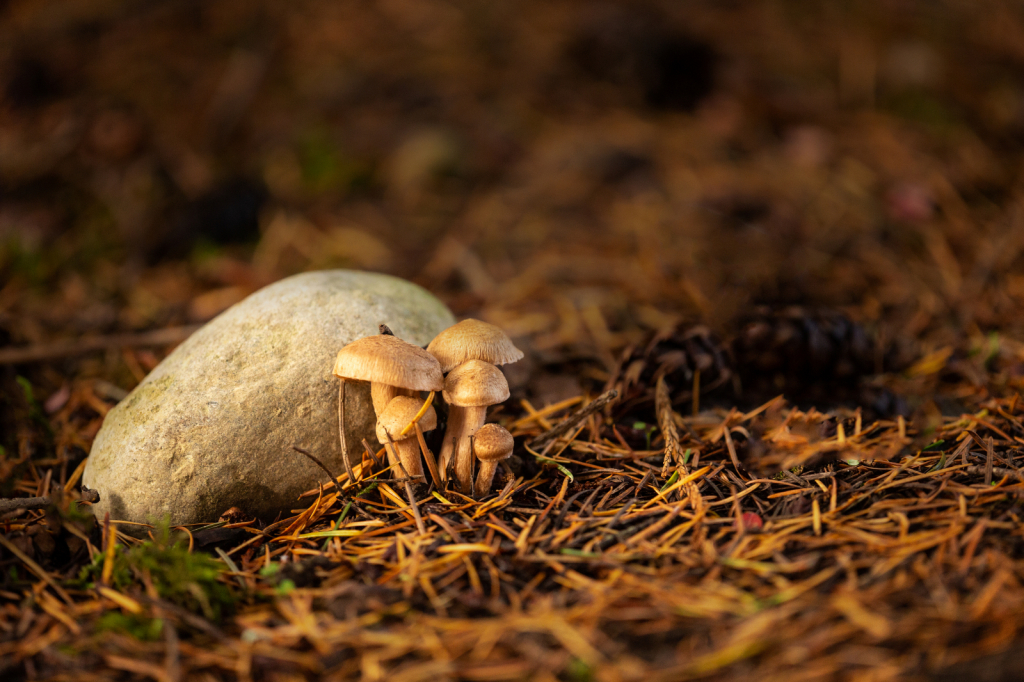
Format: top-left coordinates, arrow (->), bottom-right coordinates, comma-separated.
0,0 -> 1024,682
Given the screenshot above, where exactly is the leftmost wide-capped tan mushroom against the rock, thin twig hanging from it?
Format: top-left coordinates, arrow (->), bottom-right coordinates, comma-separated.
334,334 -> 444,480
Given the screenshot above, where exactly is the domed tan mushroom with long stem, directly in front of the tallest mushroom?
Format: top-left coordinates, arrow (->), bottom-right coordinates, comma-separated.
438,359 -> 509,493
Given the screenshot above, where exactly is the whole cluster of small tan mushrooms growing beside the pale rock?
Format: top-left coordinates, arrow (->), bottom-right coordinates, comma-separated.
334,319 -> 523,496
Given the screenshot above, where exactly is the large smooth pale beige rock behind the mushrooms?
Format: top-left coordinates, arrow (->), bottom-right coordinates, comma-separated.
83,270 -> 455,531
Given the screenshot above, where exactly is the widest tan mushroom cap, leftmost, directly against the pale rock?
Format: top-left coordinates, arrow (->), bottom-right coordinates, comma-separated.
334,334 -> 444,391
